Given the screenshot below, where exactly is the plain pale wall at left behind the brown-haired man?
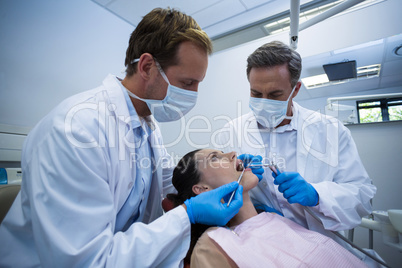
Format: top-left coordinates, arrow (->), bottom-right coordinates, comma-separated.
0,0 -> 133,127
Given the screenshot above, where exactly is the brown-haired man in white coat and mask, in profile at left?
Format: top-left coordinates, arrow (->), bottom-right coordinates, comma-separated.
0,9 -> 242,267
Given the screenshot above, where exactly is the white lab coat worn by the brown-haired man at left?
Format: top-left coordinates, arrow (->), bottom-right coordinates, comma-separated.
0,75 -> 190,267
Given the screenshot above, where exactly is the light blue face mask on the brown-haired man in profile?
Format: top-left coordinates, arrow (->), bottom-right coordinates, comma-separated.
127,59 -> 197,122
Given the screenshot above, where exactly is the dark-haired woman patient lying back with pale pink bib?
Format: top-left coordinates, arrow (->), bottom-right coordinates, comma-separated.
167,149 -> 365,268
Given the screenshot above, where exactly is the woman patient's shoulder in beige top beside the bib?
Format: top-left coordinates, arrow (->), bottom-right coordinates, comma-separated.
190,227 -> 238,268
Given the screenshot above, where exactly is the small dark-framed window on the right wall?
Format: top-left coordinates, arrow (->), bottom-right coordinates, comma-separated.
356,98 -> 402,123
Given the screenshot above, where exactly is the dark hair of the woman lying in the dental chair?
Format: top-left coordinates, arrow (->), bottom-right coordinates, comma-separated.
167,150 -> 210,264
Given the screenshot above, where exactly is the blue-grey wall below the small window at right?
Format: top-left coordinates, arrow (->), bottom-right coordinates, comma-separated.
347,121 -> 402,267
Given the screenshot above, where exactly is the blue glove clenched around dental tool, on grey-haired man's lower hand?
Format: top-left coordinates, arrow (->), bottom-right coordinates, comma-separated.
272,171 -> 318,207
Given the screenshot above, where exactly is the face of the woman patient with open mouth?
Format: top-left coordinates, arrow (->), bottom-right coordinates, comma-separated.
195,149 -> 258,191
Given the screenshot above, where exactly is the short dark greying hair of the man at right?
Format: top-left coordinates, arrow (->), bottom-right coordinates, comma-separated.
247,41 -> 302,87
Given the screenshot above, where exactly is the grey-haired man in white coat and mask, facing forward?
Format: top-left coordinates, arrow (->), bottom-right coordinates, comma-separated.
215,41 -> 376,264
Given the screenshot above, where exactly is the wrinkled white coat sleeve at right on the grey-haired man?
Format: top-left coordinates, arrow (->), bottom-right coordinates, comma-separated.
312,123 -> 376,230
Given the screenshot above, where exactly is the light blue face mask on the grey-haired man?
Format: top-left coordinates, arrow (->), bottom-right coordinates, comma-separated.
249,86 -> 296,128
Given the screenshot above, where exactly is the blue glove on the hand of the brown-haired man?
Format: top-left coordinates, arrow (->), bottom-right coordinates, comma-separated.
184,181 -> 243,226
